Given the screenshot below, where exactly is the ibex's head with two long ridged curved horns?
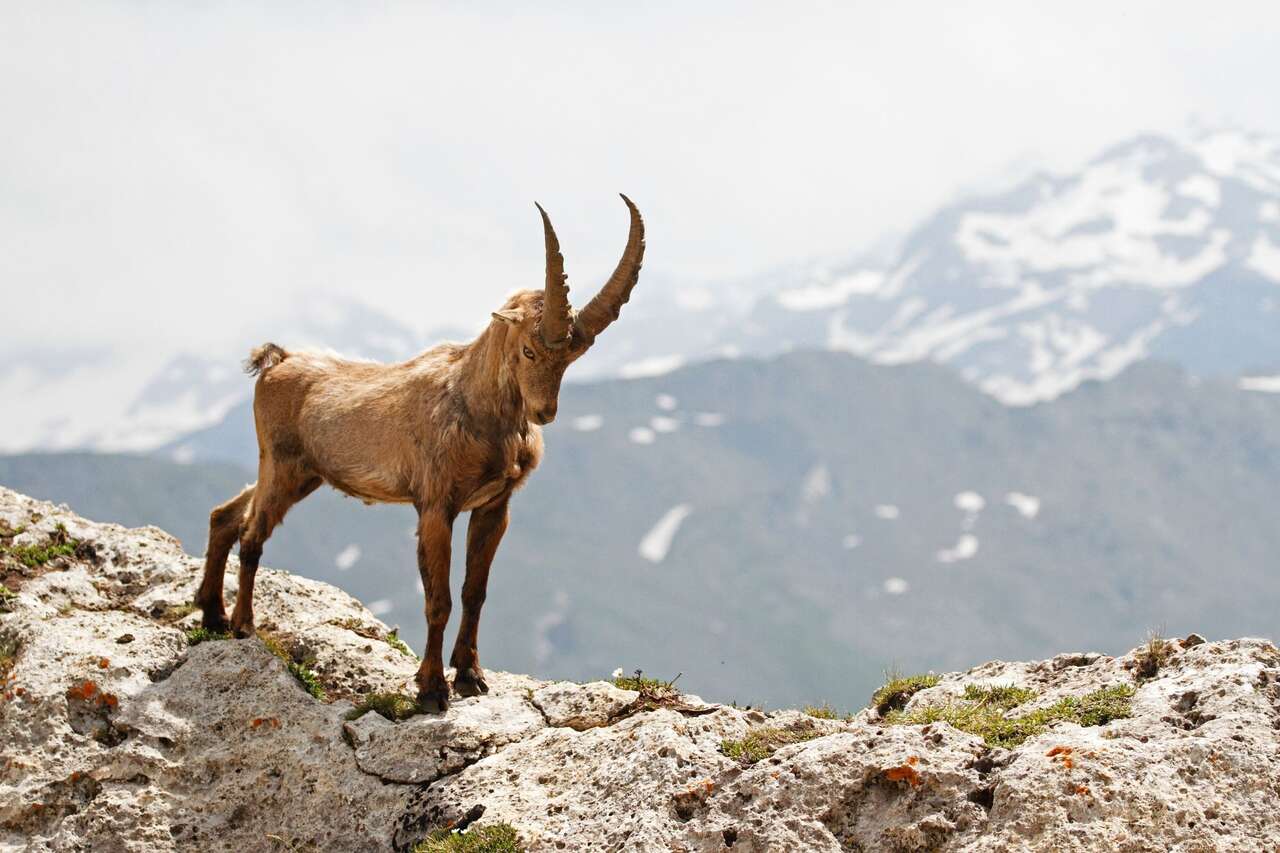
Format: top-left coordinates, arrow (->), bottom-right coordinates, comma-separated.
493,196 -> 644,424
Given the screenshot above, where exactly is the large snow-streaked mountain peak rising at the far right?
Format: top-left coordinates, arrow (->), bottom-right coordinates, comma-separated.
755,131 -> 1280,405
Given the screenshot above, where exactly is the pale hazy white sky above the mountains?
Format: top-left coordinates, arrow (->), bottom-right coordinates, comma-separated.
0,0 -> 1280,355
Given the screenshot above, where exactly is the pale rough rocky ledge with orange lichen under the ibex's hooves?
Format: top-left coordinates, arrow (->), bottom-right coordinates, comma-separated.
0,489 -> 1280,850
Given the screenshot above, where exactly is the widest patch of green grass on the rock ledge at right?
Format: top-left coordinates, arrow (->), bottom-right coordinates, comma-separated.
884,684 -> 1134,749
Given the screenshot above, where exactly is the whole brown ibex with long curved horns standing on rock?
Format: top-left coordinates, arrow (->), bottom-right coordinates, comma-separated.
196,196 -> 644,712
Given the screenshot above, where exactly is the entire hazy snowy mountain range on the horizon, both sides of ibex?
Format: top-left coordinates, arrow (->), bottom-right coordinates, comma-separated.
0,129 -> 1280,452
